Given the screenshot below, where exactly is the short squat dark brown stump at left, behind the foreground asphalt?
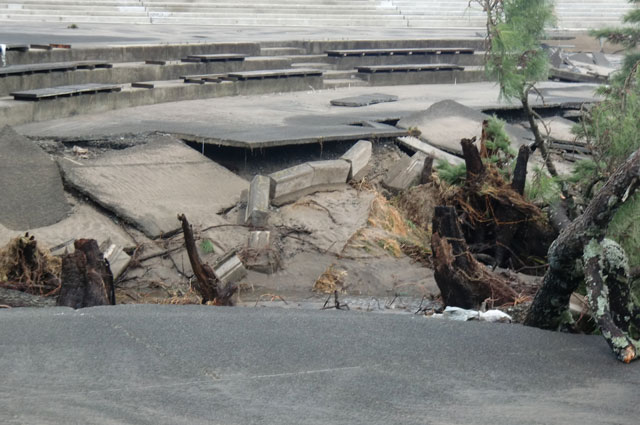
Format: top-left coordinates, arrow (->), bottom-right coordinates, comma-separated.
57,239 -> 115,309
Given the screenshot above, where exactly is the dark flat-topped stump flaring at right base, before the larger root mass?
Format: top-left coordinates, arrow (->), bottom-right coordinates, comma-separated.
431,206 -> 518,309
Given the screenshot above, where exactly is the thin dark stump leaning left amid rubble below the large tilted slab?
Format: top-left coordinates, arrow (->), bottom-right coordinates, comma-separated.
178,214 -> 238,306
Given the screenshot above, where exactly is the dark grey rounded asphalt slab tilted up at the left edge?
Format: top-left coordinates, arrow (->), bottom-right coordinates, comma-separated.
0,126 -> 71,230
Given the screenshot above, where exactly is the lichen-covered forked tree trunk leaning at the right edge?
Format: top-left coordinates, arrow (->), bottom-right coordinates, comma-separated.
525,150 -> 640,361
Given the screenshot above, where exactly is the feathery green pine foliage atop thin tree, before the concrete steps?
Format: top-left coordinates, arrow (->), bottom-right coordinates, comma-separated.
486,0 -> 554,99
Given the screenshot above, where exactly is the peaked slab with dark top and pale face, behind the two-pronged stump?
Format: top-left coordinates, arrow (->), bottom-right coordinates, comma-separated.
398,100 -> 533,154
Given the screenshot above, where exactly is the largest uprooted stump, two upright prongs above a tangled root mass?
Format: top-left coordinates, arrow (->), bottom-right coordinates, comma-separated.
445,138 -> 556,271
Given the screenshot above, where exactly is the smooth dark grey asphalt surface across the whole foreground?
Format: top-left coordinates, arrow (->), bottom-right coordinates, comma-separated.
0,305 -> 640,425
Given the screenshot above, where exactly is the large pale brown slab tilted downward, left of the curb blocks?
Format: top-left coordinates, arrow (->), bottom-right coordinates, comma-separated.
59,135 -> 248,238
